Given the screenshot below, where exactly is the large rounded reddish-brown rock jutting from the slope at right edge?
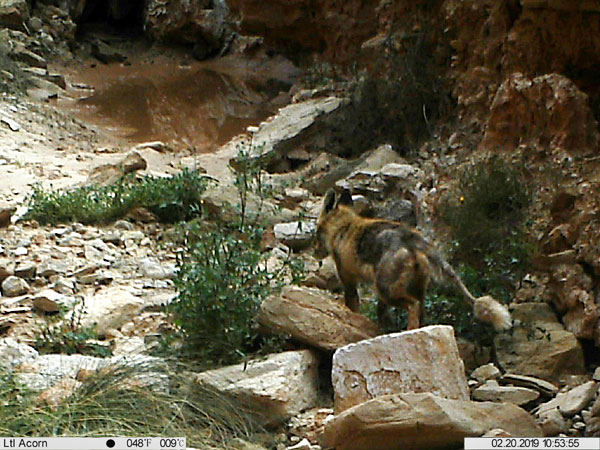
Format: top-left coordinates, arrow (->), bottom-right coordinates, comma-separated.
481,73 -> 600,153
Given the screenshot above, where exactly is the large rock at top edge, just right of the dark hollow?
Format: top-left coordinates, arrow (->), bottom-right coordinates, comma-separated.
144,0 -> 233,60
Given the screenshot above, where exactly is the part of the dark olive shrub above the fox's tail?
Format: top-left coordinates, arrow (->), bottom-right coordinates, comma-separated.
441,156 -> 532,299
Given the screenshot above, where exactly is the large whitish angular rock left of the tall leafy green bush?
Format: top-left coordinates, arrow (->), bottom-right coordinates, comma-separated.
76,287 -> 144,336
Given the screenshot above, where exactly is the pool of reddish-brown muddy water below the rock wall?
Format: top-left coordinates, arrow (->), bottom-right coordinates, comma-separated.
66,55 -> 294,152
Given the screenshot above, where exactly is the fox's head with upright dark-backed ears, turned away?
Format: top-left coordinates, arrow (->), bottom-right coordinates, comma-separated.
316,189 -> 355,256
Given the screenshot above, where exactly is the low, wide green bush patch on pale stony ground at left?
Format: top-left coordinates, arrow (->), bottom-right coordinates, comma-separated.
24,170 -> 208,224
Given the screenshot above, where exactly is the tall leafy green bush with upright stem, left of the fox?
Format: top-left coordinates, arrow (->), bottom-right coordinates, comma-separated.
168,148 -> 302,365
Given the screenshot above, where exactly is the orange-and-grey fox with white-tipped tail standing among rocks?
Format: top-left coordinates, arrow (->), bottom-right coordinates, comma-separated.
316,189 -> 512,331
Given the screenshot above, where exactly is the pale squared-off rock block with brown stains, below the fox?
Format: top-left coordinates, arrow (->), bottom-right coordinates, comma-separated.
331,325 -> 469,413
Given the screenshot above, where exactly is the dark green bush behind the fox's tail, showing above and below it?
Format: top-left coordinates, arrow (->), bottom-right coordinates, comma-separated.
434,156 -> 533,341
